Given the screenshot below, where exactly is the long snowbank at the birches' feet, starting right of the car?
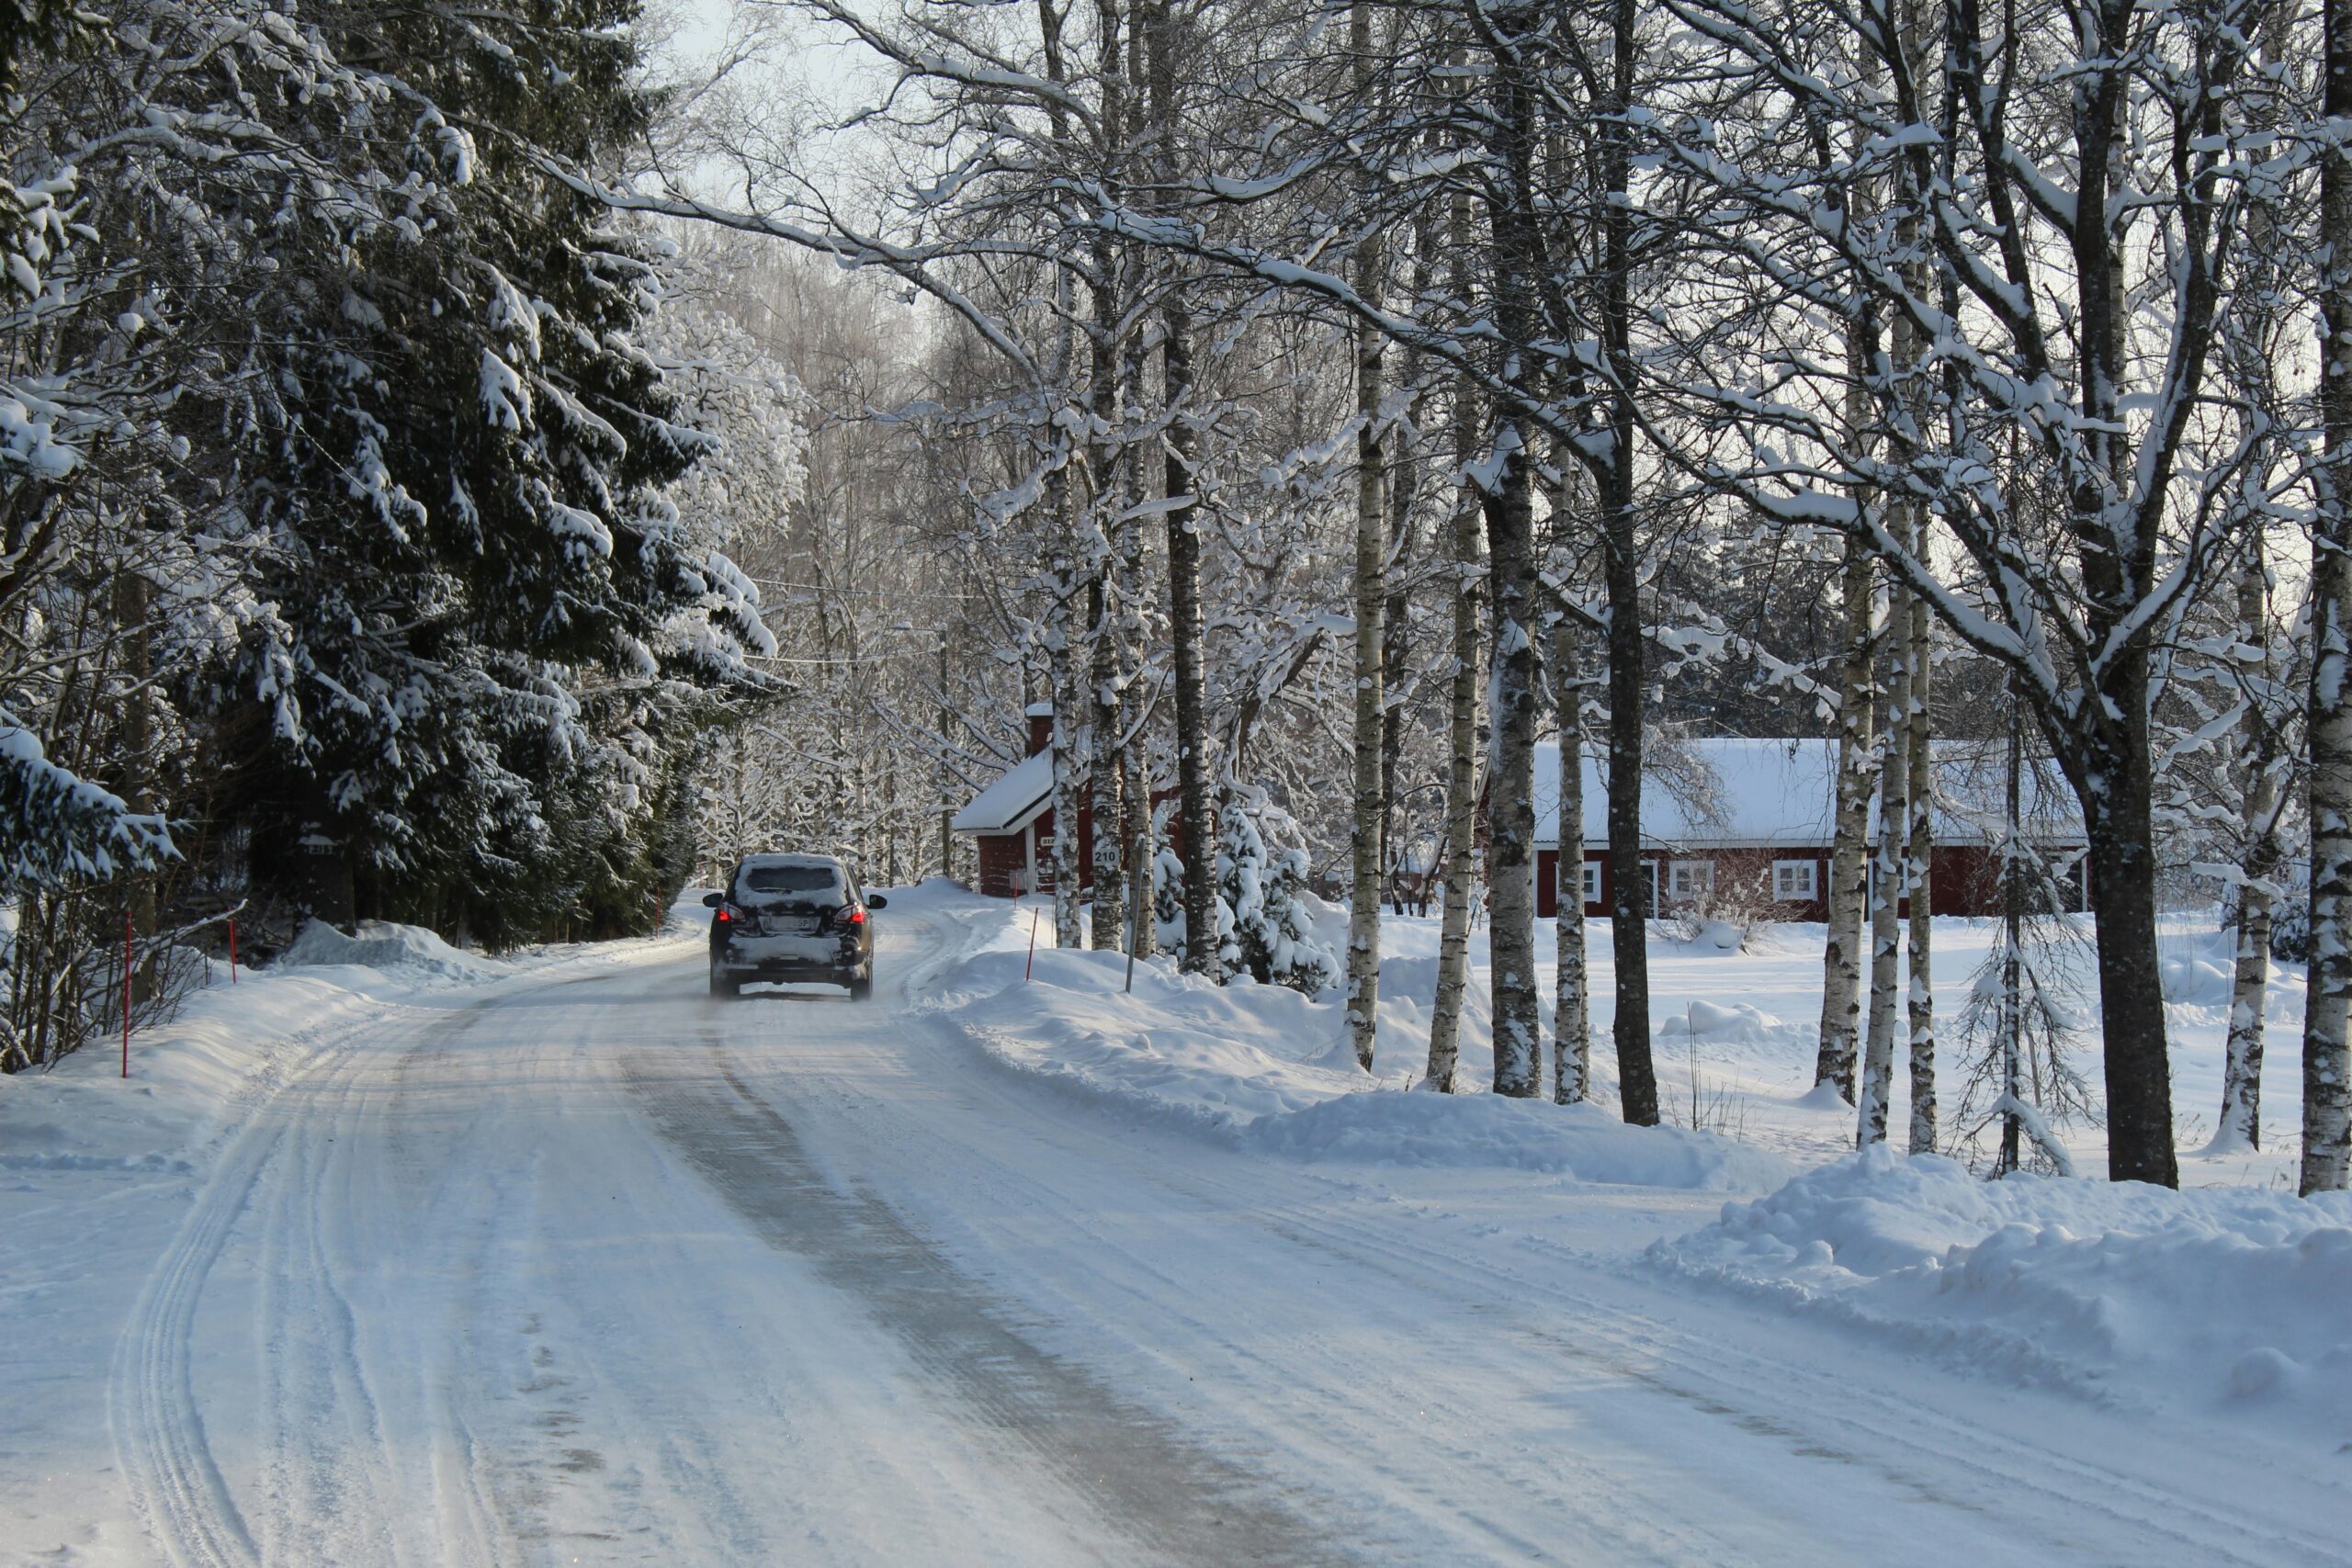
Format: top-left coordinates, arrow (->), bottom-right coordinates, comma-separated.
912,894 -> 1790,1192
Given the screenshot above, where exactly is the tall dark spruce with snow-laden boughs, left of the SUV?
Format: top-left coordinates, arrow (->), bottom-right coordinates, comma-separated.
188,0 -> 760,936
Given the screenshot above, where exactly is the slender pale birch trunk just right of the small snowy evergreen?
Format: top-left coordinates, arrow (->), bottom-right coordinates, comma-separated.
1348,0 -> 1387,1072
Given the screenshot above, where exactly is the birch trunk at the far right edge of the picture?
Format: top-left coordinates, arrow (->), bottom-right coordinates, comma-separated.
2301,0 -> 2352,1194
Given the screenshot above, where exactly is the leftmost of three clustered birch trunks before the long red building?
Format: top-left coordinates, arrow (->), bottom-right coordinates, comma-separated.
1814,536 -> 1877,1105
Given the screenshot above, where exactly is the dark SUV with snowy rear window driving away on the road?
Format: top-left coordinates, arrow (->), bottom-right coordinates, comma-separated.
703,856 -> 887,1001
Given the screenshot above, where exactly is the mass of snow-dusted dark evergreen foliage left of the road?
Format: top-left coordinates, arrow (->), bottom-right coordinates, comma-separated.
0,0 -> 790,1066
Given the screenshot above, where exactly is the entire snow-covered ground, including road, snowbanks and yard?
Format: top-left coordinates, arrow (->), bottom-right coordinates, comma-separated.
0,886 -> 2352,1563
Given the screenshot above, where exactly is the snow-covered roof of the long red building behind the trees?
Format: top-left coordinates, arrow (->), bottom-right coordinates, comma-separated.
1536,739 -> 2082,849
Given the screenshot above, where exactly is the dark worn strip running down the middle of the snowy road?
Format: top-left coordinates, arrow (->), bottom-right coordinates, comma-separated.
621,1043 -> 1352,1563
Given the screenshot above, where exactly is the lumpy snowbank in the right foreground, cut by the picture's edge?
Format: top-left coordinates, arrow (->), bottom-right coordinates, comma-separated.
1649,1145 -> 2352,1441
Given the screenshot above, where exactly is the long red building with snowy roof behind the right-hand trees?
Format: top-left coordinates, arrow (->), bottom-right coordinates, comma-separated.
1536,739 -> 2088,919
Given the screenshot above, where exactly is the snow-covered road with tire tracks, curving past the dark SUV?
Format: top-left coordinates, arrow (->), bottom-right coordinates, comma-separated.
59,903 -> 2347,1565
